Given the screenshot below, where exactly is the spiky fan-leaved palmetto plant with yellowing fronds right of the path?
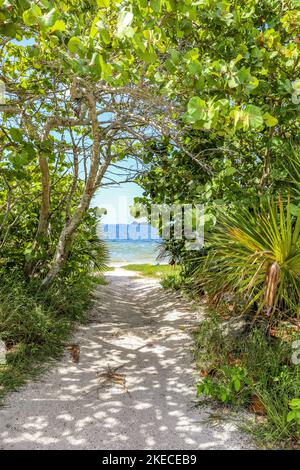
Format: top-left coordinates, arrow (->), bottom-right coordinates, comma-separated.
195,199 -> 300,317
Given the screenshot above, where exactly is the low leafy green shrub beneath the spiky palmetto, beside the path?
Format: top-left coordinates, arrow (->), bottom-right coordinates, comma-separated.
195,313 -> 300,446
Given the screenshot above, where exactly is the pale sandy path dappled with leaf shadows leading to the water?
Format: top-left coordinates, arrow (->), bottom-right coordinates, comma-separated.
0,268 -> 249,449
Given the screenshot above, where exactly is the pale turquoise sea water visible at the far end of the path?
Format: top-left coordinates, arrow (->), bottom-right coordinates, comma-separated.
106,240 -> 166,266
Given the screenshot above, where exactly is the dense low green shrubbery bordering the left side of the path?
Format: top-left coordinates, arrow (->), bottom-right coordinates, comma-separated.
0,273 -> 99,398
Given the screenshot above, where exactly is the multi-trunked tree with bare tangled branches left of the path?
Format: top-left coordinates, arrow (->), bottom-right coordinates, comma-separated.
1,2 -> 177,286
